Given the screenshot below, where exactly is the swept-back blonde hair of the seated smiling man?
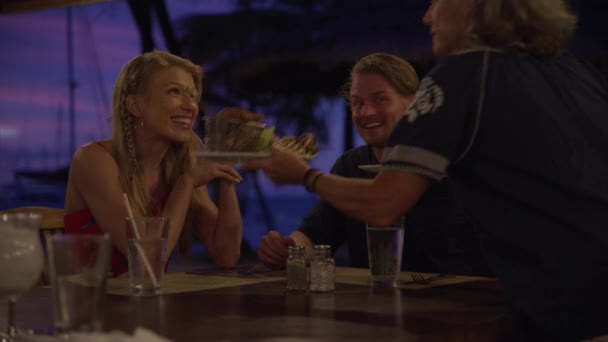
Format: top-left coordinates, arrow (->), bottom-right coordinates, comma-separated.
341,53 -> 420,99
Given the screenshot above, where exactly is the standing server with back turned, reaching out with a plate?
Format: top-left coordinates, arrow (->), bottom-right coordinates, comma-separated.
249,0 -> 608,341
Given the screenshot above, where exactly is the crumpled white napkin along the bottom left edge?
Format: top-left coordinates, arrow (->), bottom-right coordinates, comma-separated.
17,327 -> 171,342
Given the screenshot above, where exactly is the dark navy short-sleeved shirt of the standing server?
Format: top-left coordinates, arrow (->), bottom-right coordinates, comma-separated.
383,51 -> 608,339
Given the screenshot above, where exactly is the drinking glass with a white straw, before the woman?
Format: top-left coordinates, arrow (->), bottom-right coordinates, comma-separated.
127,216 -> 169,296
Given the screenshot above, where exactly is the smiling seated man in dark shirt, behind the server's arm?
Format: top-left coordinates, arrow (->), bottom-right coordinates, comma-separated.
258,53 -> 489,274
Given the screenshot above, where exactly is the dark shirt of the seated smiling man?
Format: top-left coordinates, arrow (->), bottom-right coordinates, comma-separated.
298,145 -> 491,275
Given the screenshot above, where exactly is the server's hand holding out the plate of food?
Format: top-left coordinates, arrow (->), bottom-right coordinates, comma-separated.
243,141 -> 310,184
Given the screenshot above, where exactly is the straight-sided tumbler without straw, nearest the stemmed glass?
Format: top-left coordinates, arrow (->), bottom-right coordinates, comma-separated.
47,234 -> 112,334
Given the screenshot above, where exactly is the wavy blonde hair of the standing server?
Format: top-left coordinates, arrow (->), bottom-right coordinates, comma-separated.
464,0 -> 577,56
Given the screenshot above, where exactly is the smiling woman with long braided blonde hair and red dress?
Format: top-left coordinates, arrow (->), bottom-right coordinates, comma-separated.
64,51 -> 243,275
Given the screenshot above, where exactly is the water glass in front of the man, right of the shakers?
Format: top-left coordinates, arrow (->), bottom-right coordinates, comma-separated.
366,217 -> 404,287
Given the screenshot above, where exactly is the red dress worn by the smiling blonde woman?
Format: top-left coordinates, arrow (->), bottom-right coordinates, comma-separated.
63,193 -> 169,277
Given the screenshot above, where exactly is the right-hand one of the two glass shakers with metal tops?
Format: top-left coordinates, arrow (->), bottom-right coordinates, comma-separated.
310,245 -> 336,292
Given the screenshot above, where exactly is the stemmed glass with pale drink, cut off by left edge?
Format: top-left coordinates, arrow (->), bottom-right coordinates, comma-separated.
0,213 -> 44,341
